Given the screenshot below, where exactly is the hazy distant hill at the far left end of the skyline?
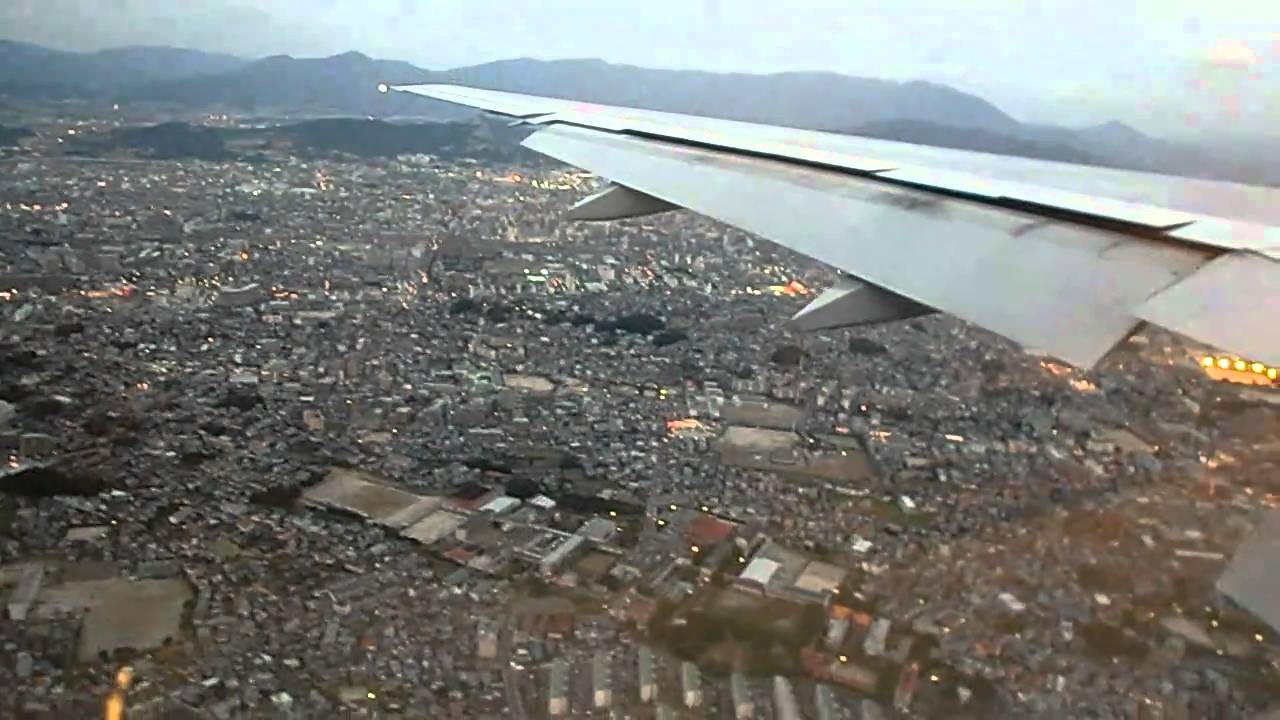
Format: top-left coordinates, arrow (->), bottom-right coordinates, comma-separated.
0,40 -> 248,99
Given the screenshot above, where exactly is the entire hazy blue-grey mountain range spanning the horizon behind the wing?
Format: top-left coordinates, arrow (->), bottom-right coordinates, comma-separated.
0,41 -> 1280,186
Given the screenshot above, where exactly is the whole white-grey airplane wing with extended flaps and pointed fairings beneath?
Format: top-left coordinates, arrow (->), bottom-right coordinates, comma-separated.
383,85 -> 1280,368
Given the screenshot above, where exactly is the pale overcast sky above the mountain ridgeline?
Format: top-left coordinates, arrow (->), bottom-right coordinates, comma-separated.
0,0 -> 1280,135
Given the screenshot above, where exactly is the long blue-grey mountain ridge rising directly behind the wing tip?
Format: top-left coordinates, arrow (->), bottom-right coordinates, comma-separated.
122,53 -> 1018,132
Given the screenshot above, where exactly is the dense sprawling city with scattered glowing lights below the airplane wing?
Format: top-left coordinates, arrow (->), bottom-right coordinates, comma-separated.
0,96 -> 1280,720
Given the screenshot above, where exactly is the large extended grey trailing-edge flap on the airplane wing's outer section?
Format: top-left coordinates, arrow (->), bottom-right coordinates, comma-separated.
525,126 -> 1208,366
